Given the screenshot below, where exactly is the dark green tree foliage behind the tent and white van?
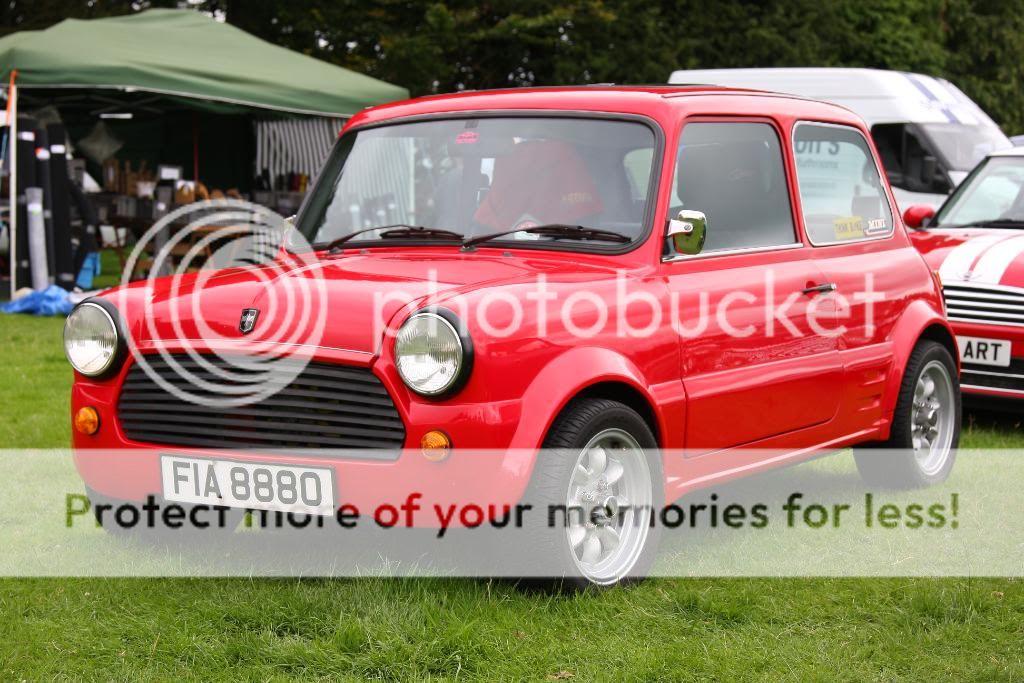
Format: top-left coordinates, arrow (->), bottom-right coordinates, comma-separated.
6,0 -> 1024,133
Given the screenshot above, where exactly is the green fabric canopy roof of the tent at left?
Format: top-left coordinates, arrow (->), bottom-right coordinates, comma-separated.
0,9 -> 409,118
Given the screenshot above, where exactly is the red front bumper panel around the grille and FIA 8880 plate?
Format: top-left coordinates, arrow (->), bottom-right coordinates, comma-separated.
71,351 -> 540,519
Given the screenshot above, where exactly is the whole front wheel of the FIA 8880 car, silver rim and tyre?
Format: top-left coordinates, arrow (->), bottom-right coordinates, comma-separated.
512,398 -> 664,589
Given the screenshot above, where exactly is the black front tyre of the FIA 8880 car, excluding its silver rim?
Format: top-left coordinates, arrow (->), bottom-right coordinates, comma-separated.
511,398 -> 664,592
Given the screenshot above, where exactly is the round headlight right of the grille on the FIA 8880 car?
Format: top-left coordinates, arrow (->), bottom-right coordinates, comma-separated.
394,312 -> 469,396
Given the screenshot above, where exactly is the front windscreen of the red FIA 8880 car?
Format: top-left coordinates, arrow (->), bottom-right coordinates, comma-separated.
298,117 -> 655,248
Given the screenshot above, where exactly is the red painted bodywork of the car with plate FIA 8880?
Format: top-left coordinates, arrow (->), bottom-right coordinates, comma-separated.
72,87 -> 954,520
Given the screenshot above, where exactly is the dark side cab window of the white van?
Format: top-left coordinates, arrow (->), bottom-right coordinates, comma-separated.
871,123 -> 952,195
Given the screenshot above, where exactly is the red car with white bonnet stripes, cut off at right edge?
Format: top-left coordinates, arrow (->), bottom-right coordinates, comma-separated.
904,147 -> 1024,399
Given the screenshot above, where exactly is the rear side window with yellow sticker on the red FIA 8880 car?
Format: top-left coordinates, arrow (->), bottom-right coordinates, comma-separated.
793,123 -> 893,245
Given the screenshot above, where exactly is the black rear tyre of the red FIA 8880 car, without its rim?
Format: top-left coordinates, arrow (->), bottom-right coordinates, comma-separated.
854,340 -> 962,488
